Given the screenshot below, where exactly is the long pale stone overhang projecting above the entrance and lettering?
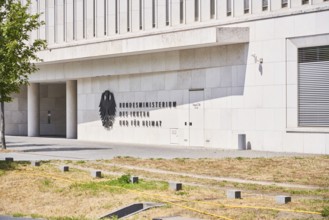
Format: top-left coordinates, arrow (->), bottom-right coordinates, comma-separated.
38,27 -> 249,65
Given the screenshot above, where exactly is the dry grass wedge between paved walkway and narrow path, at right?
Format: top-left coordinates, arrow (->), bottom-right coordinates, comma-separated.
108,156 -> 329,187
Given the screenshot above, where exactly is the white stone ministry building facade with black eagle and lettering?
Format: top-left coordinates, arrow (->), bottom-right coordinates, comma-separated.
5,0 -> 329,154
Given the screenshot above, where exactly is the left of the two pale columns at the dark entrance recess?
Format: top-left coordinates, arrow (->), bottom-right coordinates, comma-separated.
27,83 -> 40,137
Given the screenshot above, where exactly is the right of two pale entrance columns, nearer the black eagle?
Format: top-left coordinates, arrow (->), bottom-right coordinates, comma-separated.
66,80 -> 78,139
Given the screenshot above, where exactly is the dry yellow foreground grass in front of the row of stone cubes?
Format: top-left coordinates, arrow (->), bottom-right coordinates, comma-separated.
0,159 -> 329,219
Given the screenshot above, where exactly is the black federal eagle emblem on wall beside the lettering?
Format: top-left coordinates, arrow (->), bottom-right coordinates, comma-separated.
99,90 -> 116,130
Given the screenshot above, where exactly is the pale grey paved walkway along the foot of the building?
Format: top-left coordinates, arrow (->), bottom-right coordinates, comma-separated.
0,136 -> 314,161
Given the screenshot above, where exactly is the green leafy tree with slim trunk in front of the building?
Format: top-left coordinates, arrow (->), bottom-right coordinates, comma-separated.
0,0 -> 46,149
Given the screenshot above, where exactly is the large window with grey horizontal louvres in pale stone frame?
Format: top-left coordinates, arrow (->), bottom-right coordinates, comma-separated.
298,46 -> 329,127
